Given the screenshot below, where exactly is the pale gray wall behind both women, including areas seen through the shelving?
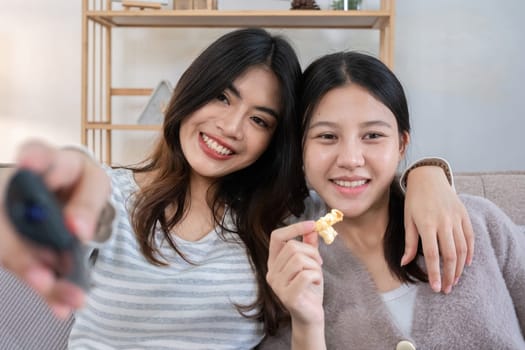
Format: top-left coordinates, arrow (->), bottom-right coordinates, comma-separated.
0,0 -> 525,171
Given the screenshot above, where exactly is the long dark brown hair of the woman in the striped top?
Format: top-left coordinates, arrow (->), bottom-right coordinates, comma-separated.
132,28 -> 307,334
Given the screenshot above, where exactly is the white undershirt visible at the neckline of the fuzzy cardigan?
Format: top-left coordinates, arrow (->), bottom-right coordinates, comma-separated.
381,284 -> 417,335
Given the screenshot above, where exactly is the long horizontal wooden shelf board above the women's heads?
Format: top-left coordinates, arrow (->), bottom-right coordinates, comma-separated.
86,10 -> 391,29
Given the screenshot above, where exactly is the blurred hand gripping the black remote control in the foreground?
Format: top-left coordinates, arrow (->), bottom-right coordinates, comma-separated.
0,141 -> 102,318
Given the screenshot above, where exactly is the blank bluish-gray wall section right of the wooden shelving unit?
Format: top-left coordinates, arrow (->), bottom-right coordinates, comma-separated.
395,0 -> 525,171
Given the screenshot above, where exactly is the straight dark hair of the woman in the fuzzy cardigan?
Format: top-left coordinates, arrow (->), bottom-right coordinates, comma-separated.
300,51 -> 428,282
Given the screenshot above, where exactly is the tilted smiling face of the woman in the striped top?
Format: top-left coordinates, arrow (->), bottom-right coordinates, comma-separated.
180,66 -> 281,186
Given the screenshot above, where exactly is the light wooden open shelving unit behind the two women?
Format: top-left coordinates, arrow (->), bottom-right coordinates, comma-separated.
81,0 -> 395,164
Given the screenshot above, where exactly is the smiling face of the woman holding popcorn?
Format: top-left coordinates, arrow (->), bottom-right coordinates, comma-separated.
303,83 -> 409,218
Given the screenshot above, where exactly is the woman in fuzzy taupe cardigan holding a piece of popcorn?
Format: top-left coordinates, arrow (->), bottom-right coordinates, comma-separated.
259,52 -> 525,350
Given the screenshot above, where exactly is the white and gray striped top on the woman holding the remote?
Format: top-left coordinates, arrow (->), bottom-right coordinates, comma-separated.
69,169 -> 263,350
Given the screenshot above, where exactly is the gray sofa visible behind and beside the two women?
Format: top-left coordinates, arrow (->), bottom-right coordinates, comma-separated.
0,171 -> 525,350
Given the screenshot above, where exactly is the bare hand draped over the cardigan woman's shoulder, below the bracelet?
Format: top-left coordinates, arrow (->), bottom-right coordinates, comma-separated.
401,160 -> 474,293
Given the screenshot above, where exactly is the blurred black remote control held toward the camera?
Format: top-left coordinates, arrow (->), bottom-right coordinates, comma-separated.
5,169 -> 89,290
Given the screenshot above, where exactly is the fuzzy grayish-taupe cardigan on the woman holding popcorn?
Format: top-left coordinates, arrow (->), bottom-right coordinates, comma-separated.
259,195 -> 525,350
